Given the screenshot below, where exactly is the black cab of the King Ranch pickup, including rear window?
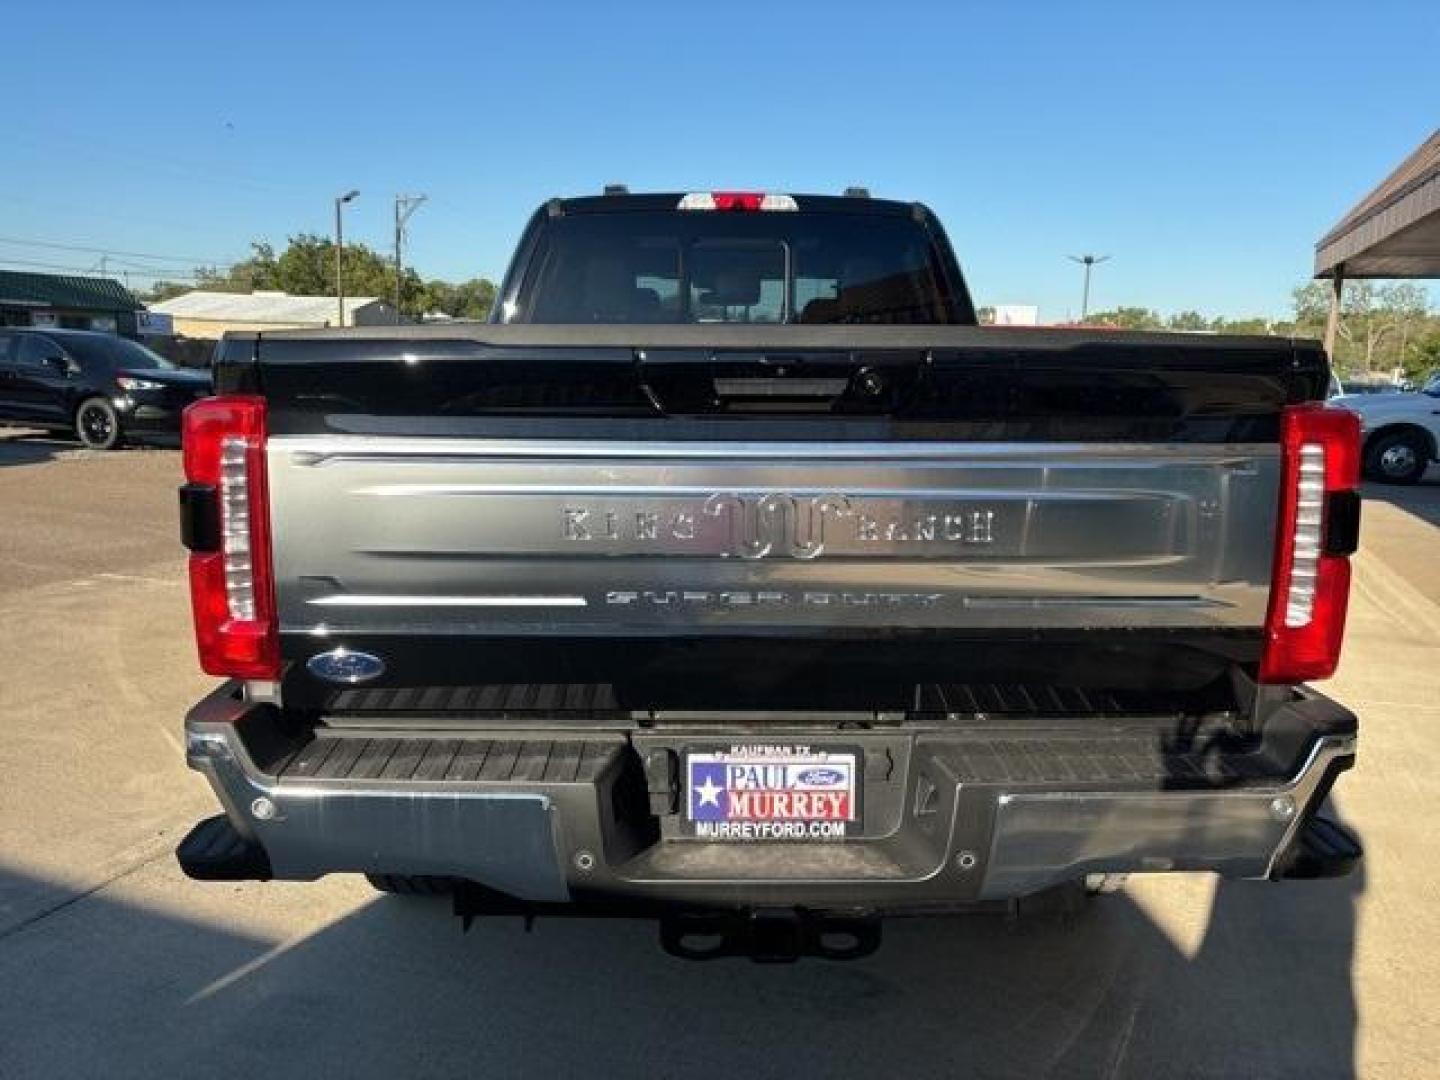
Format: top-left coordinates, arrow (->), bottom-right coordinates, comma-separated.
492,189 -> 976,325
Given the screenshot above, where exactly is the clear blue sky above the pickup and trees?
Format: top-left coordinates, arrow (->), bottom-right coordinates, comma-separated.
0,0 -> 1440,318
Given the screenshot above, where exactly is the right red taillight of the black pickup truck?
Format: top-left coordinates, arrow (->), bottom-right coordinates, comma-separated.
1260,405 -> 1359,683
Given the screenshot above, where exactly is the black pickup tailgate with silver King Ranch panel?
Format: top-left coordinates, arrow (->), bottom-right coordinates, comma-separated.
217,325 -> 1325,708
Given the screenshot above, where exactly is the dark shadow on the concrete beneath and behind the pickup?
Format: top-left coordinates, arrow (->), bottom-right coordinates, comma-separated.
0,868 -> 1364,1077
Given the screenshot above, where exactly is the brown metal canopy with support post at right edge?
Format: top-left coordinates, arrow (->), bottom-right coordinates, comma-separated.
1315,130 -> 1440,353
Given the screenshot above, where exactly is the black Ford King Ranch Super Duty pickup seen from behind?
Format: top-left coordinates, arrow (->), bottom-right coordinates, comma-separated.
179,192 -> 1359,959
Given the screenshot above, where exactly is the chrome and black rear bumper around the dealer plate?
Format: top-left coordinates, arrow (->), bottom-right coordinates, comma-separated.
186,685 -> 1355,912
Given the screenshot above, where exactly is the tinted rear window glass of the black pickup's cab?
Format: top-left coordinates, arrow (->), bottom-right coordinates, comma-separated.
505,212 -> 956,324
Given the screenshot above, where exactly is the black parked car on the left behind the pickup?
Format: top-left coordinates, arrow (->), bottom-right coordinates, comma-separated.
0,328 -> 210,449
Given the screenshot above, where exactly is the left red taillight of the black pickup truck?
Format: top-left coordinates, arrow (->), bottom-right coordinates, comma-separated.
183,395 -> 279,678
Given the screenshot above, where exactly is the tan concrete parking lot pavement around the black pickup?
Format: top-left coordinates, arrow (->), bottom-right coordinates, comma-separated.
0,433 -> 1440,1080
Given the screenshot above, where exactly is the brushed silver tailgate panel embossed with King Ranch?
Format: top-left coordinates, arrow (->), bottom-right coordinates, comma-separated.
269,436 -> 1279,636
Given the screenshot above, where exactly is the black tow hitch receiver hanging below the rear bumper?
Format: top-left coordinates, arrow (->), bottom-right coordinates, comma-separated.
660,907 -> 881,963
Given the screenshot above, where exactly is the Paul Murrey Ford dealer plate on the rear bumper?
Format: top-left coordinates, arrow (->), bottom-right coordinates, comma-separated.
685,746 -> 861,841
